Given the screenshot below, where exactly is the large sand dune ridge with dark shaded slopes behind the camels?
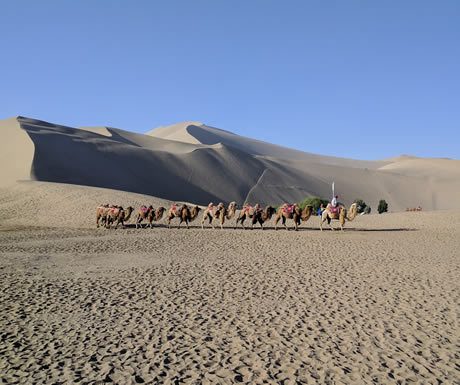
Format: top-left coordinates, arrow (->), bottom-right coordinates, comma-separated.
0,117 -> 460,211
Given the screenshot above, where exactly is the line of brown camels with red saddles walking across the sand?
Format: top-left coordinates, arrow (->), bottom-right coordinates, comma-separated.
96,202 -> 357,231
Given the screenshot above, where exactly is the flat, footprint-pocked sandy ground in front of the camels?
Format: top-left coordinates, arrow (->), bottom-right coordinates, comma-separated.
0,185 -> 460,384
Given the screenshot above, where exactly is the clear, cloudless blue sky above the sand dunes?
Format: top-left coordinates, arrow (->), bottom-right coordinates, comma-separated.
0,0 -> 460,159
